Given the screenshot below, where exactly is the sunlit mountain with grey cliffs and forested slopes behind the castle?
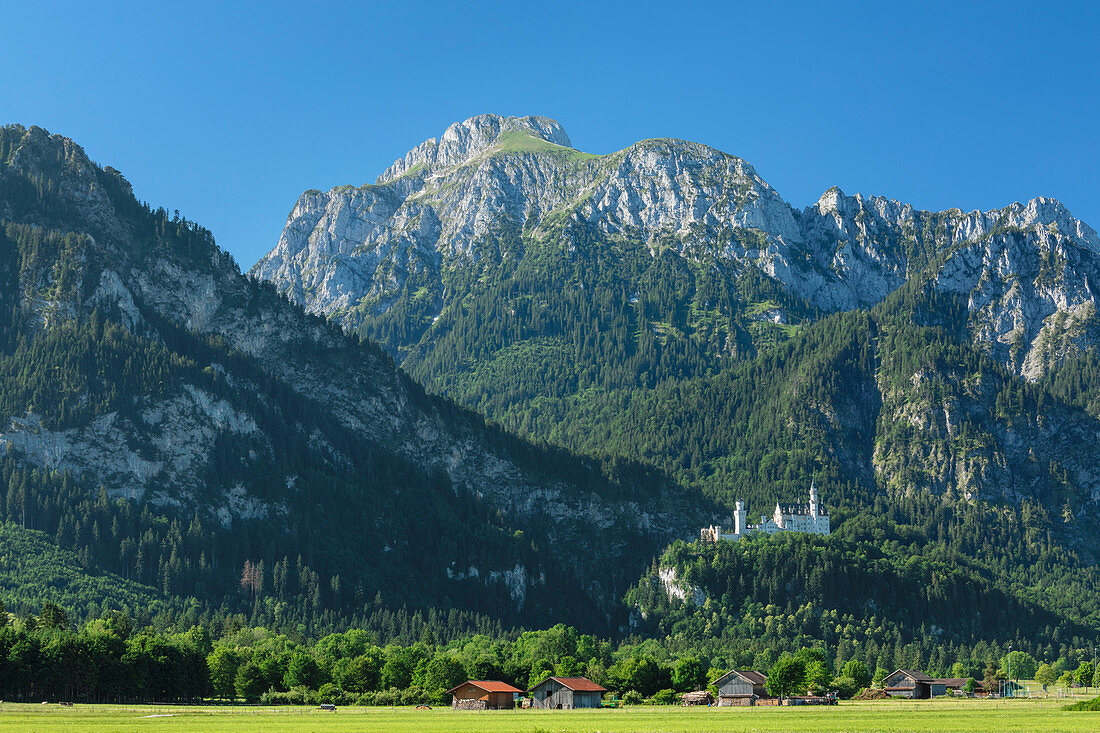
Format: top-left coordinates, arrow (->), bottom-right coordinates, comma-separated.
252,116 -> 1100,549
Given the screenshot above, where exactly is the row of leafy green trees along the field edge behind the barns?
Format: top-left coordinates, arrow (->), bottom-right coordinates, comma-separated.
0,603 -> 1100,704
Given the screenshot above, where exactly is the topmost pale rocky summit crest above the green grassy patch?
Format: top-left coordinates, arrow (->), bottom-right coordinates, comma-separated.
376,114 -> 573,184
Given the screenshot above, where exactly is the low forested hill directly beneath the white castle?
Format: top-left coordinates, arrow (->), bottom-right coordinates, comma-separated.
627,533 -> 1098,669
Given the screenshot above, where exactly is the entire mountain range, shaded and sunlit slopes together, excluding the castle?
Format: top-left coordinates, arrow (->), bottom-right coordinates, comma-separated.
0,114 -> 1100,658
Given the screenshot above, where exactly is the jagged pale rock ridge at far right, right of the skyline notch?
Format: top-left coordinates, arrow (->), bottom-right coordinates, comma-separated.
802,188 -> 1100,380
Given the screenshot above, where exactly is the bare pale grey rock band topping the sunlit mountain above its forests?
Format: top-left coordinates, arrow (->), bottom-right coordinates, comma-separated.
251,114 -> 1100,380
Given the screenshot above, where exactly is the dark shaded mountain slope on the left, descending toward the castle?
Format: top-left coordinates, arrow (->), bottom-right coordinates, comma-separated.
0,125 -> 707,625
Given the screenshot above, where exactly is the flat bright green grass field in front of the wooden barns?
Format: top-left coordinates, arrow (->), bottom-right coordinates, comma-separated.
0,699 -> 1100,733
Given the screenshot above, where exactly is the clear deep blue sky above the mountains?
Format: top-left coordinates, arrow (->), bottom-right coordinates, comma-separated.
0,0 -> 1100,267
